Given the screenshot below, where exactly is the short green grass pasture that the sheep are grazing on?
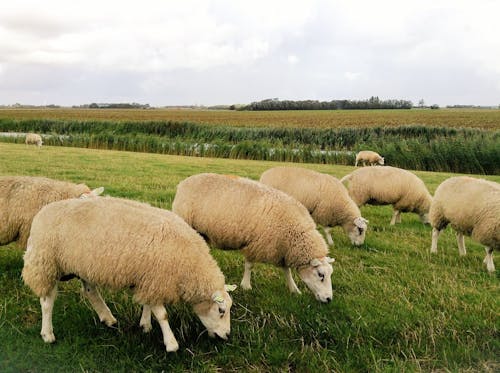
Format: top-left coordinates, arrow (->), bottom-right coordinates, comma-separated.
0,143 -> 500,372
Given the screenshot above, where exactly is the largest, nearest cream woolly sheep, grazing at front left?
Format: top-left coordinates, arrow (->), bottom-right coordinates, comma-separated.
22,197 -> 234,351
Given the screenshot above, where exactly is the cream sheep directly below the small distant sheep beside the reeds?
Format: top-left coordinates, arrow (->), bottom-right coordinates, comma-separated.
340,166 -> 432,225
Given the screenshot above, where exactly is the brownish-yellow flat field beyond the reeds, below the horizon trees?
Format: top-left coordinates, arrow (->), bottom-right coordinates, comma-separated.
0,108 -> 500,130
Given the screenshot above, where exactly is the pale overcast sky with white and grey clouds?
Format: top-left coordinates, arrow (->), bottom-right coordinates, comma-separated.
0,0 -> 500,106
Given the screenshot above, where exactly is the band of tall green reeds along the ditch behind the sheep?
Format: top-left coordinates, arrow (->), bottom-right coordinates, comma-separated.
0,119 -> 500,174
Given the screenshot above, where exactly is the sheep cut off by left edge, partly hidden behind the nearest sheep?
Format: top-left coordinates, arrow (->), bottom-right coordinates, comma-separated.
0,176 -> 104,249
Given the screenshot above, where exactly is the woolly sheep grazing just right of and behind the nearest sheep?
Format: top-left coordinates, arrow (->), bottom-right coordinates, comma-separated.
172,173 -> 334,302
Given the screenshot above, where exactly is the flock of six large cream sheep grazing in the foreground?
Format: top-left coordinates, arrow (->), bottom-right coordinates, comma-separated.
0,155 -> 500,351
